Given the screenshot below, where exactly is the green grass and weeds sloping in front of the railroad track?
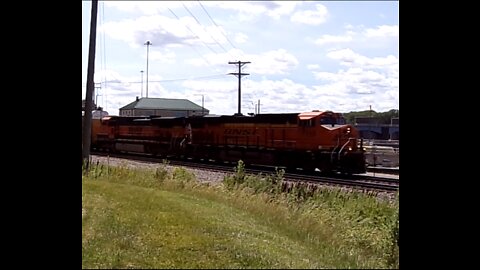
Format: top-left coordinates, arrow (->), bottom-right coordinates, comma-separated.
82,161 -> 398,268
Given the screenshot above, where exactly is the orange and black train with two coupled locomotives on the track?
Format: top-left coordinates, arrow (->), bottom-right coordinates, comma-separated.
92,111 -> 366,173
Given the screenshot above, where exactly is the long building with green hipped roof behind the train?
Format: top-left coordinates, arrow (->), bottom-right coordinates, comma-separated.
119,97 -> 210,117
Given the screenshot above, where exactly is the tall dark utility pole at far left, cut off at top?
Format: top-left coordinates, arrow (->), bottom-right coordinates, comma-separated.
82,0 -> 98,169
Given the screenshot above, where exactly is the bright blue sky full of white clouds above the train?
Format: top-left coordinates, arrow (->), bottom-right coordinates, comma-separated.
82,1 -> 399,115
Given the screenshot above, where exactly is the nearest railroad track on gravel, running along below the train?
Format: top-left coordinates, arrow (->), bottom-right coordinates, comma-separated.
92,152 -> 399,193
